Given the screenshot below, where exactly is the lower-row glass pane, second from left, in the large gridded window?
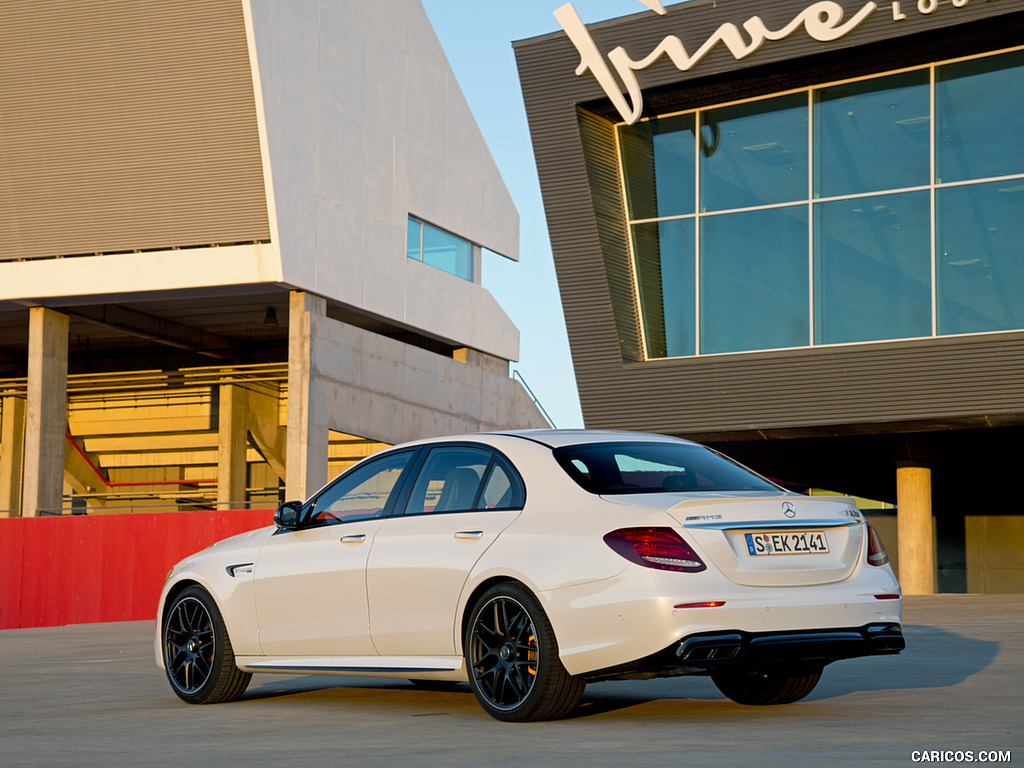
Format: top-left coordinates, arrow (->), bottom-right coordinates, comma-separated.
700,206 -> 810,353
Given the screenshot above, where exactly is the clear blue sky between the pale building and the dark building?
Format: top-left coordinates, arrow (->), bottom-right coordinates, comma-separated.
422,0 -> 646,428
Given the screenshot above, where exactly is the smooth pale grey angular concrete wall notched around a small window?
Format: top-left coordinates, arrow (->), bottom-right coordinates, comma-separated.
251,0 -> 519,359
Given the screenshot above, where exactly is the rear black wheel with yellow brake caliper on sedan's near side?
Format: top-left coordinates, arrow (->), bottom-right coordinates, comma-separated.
463,582 -> 586,723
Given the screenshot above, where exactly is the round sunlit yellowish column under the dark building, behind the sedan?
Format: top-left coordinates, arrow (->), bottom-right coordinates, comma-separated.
896,463 -> 935,595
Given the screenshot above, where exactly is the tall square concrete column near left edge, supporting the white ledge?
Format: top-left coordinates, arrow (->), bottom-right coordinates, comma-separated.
22,306 -> 69,517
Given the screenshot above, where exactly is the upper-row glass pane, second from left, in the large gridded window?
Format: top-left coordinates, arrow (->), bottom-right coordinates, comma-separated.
700,93 -> 808,214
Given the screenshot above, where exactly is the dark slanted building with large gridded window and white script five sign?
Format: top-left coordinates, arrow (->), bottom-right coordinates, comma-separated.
516,0 -> 1024,592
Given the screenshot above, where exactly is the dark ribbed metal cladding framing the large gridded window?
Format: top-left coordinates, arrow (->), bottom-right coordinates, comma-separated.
514,0 -> 1024,441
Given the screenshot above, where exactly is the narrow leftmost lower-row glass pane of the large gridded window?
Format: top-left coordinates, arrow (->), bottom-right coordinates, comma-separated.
633,219 -> 696,357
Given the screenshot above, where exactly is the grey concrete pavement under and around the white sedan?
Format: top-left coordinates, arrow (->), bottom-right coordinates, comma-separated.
0,595 -> 1024,768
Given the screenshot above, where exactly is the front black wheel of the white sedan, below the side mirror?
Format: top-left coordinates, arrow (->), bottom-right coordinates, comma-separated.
162,587 -> 252,703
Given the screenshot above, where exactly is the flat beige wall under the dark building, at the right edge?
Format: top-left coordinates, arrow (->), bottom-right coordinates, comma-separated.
965,515 -> 1024,594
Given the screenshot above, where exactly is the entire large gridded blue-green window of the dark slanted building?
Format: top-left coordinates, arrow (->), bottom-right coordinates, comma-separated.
618,50 -> 1024,357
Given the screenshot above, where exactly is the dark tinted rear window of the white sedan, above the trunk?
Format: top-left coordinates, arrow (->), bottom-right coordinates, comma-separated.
554,442 -> 779,494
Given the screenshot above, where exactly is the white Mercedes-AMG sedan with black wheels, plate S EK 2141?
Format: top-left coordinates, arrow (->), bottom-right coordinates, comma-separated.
156,430 -> 904,721
